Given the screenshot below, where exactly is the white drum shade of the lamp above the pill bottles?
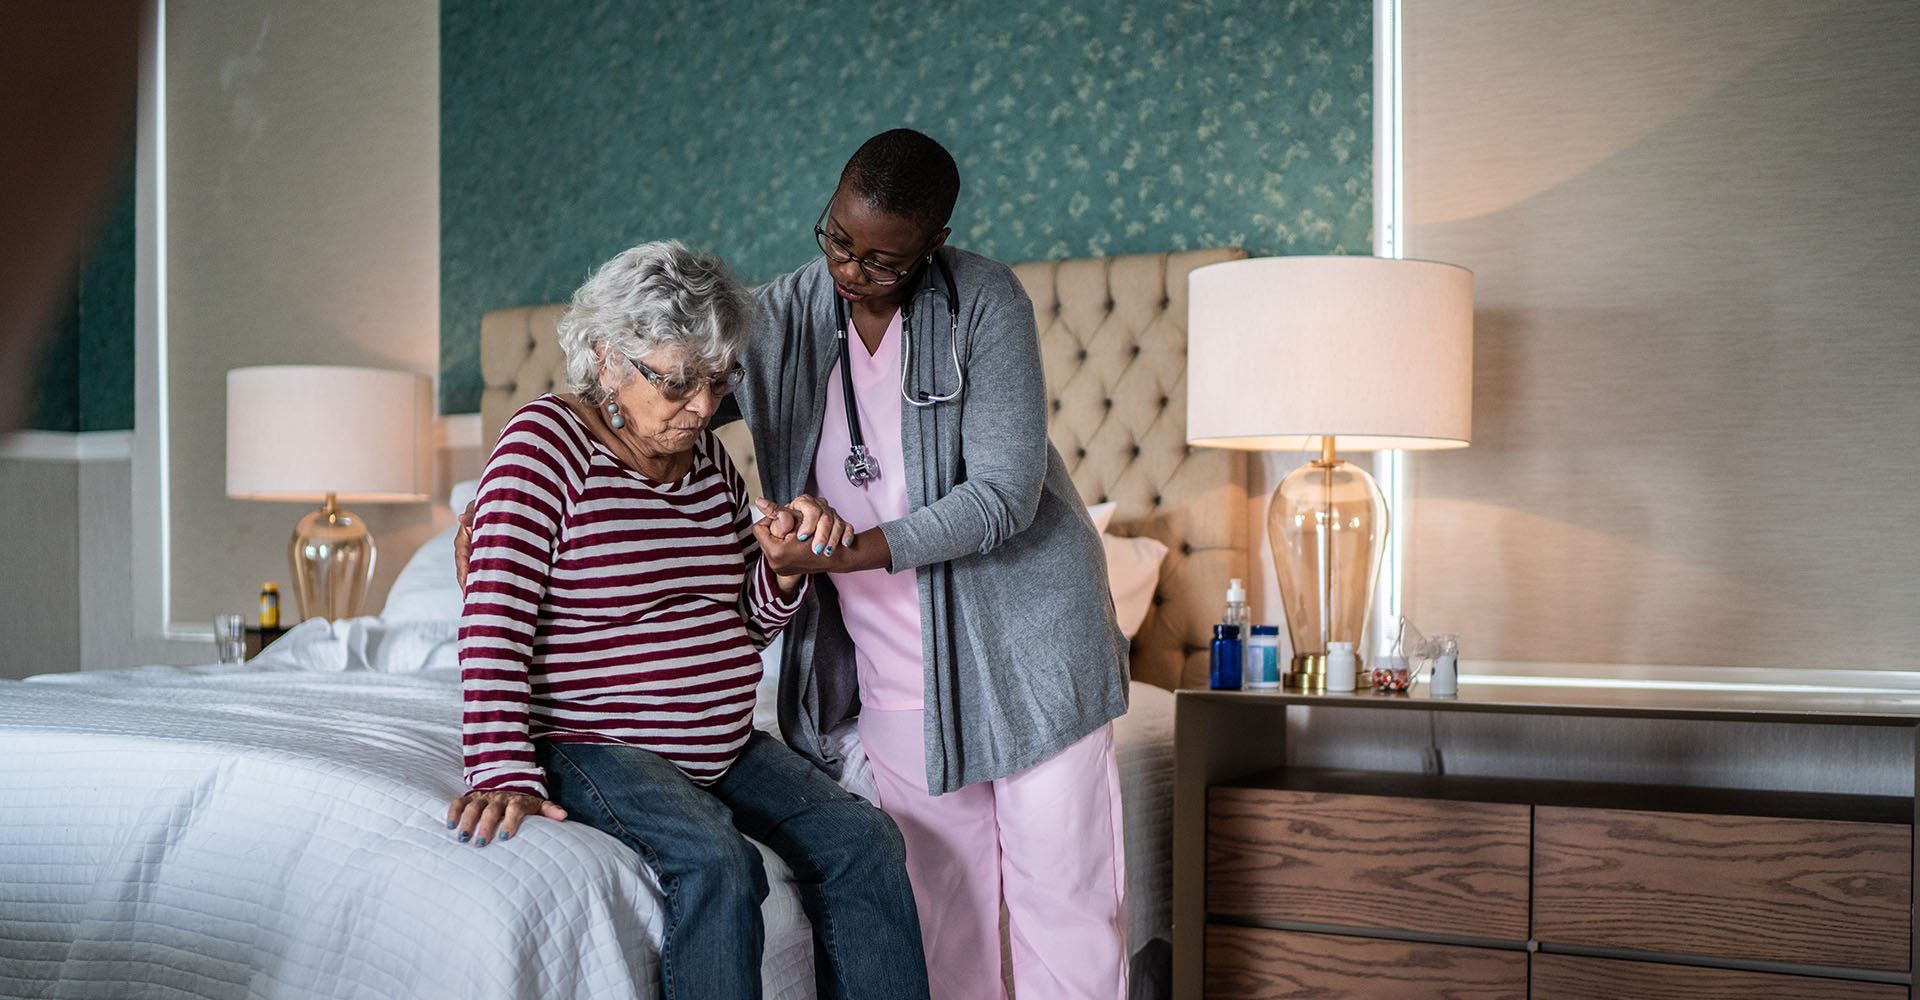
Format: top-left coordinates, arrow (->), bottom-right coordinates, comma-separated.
1187,257 -> 1473,451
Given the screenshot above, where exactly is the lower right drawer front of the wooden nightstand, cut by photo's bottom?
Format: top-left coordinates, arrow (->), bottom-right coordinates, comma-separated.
1530,954 -> 1907,1000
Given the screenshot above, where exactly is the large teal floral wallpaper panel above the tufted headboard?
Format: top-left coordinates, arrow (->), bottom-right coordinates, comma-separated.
440,0 -> 1373,413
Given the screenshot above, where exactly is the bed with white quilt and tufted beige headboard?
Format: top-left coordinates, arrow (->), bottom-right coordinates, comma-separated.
0,250 -> 1248,998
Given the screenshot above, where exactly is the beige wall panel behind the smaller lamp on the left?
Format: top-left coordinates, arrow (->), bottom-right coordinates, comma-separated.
163,0 -> 440,630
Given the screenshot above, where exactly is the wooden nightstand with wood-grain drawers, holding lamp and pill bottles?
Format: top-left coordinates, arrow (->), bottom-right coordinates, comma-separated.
1173,685 -> 1920,1000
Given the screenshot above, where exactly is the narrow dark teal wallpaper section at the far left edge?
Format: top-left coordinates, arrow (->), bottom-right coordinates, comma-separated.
27,163 -> 134,432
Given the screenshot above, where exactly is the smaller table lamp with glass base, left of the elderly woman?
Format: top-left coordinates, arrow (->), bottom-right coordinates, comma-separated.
227,365 -> 434,620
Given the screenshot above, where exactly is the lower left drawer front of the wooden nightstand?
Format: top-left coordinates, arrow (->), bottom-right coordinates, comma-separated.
1206,923 -> 1526,1000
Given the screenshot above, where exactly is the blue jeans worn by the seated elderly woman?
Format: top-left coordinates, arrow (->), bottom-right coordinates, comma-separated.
536,731 -> 927,1000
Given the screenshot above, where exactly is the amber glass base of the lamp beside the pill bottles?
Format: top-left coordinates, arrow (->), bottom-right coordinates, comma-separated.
1267,438 -> 1386,691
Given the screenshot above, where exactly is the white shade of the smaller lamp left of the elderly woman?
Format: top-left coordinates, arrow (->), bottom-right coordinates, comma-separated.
227,365 -> 434,503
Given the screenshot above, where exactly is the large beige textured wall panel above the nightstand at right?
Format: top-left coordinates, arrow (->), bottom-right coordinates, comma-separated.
1402,0 -> 1920,668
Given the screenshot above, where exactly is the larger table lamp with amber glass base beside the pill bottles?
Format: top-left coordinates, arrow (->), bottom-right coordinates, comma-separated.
1187,257 -> 1473,691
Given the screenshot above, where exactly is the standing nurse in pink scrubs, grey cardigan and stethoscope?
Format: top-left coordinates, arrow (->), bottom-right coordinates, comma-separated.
722,129 -> 1127,1000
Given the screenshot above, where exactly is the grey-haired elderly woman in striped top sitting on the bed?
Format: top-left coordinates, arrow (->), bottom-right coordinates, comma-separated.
447,242 -> 927,1000
